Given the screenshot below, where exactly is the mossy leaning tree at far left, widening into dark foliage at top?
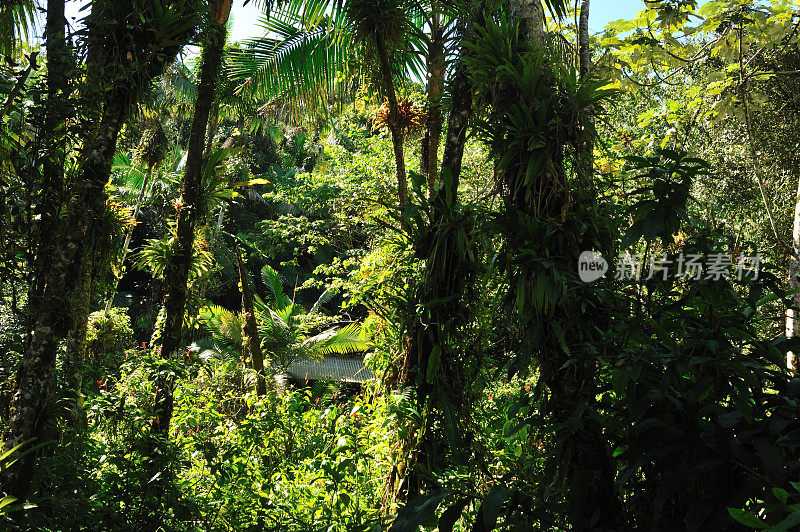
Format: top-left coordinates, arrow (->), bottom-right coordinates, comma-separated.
3,0 -> 197,500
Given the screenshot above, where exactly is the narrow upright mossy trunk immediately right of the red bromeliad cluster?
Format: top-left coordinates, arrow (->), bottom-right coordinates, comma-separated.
419,13 -> 445,201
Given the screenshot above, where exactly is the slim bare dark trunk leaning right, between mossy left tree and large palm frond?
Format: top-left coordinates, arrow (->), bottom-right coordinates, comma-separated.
153,0 -> 231,436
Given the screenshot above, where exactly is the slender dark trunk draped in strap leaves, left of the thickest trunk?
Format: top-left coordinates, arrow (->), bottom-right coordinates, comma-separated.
385,0 -> 486,502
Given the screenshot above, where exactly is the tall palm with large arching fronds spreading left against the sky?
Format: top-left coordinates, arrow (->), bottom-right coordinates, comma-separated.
231,0 -> 459,209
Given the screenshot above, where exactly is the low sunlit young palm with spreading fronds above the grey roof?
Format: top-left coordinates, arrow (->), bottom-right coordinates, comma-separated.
197,265 -> 370,386
